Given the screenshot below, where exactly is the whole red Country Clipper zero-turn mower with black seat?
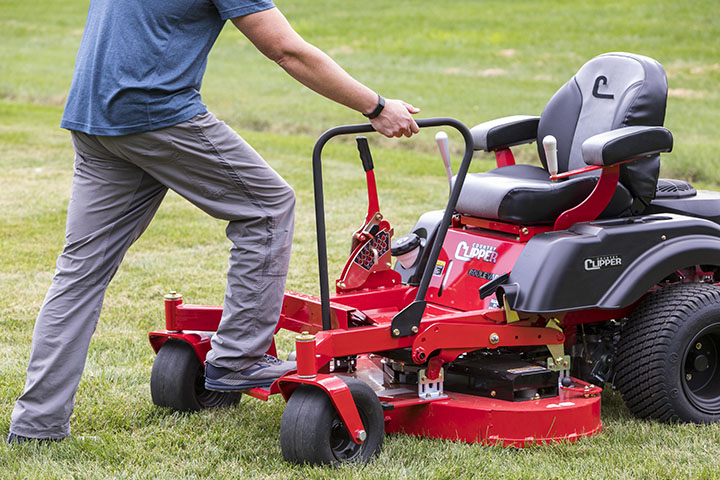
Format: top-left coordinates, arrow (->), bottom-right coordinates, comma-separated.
150,53 -> 720,463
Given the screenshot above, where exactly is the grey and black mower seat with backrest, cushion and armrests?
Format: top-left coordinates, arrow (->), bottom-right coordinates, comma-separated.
456,53 -> 672,225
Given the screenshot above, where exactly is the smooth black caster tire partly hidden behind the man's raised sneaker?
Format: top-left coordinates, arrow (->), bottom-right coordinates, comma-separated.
150,339 -> 242,412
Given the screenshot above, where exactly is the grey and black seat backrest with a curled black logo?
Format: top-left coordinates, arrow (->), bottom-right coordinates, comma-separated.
538,53 -> 667,213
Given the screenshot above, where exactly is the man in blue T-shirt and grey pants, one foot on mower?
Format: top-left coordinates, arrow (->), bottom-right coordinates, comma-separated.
8,0 -> 418,442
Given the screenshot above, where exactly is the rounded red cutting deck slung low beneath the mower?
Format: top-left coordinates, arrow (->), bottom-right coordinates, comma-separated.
239,355 -> 603,447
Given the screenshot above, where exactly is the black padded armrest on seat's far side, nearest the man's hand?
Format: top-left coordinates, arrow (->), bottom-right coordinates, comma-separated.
470,115 -> 540,152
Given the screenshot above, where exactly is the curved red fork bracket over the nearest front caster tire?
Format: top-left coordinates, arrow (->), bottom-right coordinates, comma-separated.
273,374 -> 365,444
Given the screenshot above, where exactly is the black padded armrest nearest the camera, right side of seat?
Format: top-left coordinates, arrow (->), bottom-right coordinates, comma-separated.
582,127 -> 673,166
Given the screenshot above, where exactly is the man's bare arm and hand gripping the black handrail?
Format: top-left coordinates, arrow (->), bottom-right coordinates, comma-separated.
232,8 -> 420,137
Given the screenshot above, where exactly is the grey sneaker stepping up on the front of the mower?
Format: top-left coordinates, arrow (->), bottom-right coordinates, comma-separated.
205,354 -> 297,392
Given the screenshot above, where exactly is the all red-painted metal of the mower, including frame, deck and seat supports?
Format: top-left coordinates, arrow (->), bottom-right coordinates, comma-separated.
149,144 -> 648,447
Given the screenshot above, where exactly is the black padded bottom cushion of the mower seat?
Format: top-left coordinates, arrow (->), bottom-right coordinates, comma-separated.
455,165 -> 632,225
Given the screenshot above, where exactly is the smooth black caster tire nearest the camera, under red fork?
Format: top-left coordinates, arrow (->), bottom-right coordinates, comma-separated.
280,377 -> 385,465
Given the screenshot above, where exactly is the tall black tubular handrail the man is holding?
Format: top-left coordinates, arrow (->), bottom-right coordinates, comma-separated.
313,117 -> 473,337
